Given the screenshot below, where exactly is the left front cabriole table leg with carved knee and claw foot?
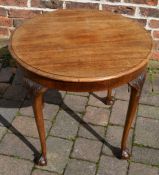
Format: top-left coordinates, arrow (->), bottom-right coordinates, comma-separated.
25,79 -> 47,166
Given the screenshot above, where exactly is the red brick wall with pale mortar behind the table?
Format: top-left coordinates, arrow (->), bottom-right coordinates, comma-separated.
0,0 -> 159,60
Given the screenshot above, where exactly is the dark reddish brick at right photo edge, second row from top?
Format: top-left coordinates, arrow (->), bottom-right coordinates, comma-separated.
140,8 -> 159,18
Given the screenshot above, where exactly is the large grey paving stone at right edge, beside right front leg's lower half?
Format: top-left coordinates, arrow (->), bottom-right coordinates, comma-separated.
135,117 -> 159,148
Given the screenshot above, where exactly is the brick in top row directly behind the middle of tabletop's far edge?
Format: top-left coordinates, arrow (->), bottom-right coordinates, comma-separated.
66,2 -> 99,9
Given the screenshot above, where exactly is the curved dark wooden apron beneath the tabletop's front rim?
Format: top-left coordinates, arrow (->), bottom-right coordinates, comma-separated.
18,65 -> 147,92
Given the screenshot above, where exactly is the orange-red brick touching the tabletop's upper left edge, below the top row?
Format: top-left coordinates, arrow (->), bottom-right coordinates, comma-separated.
9,9 -> 40,18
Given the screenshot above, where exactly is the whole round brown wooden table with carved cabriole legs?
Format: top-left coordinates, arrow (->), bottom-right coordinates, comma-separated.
9,9 -> 152,165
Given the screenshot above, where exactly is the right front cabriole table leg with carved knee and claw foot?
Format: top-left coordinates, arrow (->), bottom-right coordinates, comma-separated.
121,72 -> 146,159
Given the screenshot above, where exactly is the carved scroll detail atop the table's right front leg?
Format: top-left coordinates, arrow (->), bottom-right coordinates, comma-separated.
128,71 -> 146,96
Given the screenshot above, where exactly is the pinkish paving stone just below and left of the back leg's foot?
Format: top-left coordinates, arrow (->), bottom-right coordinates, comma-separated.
83,106 -> 110,126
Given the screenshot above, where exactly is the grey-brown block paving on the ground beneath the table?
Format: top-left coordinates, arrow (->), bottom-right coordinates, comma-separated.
0,44 -> 159,175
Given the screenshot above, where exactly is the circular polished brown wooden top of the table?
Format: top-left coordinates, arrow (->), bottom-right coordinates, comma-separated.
10,9 -> 152,82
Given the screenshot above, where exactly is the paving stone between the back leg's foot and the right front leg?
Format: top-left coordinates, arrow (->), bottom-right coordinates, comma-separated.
115,85 -> 130,101
